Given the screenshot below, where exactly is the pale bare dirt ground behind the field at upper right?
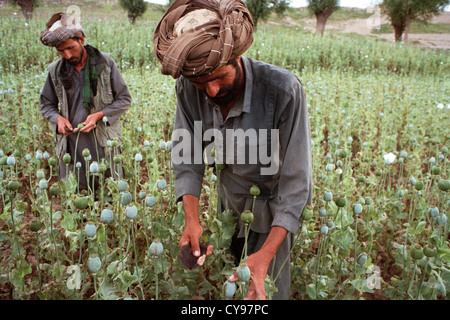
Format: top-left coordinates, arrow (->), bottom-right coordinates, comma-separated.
283,12 -> 450,49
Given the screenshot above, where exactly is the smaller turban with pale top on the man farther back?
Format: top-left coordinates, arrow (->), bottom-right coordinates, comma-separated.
41,12 -> 85,47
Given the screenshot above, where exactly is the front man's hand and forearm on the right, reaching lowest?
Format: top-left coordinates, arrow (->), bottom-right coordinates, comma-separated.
228,227 -> 287,300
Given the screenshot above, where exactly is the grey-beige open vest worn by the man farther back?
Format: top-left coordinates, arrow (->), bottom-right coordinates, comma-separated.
48,52 -> 122,159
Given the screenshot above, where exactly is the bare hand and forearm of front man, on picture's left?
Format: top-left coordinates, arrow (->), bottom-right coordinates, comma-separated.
179,195 -> 213,257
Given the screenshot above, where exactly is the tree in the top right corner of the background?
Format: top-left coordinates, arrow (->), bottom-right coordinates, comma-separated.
381,0 -> 450,43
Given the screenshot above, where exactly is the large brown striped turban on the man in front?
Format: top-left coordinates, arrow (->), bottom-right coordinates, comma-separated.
153,0 -> 253,79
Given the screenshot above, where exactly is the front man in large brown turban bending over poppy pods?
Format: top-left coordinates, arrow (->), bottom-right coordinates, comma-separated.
154,0 -> 312,299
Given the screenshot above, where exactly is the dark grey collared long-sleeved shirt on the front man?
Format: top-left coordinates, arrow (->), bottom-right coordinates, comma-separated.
172,57 -> 312,236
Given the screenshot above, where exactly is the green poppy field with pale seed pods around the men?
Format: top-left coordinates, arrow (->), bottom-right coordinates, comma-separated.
0,1 -> 450,300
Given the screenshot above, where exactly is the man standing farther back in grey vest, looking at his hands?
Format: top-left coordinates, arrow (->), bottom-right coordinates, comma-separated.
40,13 -> 131,189
